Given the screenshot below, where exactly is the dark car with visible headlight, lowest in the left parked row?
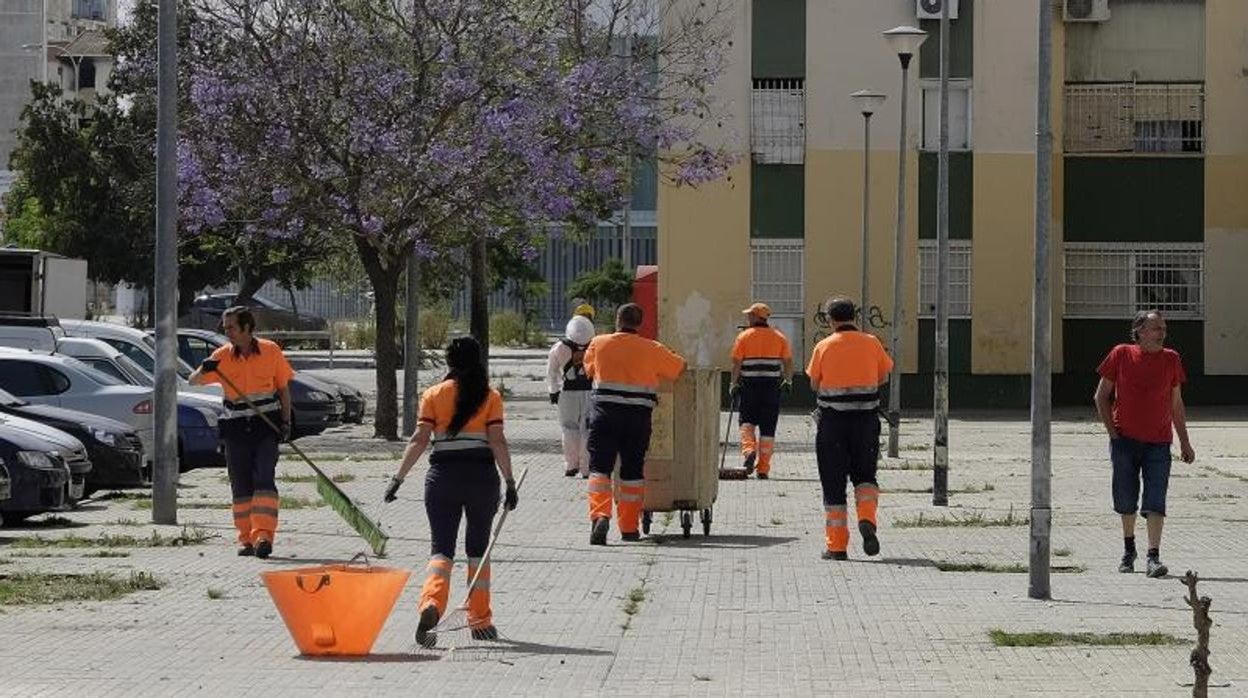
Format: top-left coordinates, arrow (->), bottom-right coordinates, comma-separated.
0,425 -> 70,526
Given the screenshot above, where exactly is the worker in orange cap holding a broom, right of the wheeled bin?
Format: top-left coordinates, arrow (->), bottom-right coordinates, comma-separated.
729,303 -> 792,479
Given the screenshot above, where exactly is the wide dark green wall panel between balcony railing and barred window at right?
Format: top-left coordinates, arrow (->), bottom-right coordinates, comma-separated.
1062,156 -> 1204,242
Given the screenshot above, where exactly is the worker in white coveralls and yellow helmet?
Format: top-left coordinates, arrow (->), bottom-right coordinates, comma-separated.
547,305 -> 594,477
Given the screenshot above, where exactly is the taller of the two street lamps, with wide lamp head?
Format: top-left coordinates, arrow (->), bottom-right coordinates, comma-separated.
884,26 -> 927,458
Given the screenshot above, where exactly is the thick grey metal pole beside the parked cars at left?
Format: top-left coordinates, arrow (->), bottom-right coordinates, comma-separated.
151,0 -> 177,524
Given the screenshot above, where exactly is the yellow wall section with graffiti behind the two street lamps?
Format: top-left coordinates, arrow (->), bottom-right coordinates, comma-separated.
806,150 -> 919,372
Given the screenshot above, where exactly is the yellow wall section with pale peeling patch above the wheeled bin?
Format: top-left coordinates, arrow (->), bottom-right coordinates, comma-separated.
659,161 -> 750,368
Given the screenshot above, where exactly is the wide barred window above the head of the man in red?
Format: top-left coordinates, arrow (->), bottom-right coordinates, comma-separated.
1065,242 -> 1204,320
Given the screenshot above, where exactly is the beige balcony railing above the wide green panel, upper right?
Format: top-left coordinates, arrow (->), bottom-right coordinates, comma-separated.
1065,82 -> 1204,154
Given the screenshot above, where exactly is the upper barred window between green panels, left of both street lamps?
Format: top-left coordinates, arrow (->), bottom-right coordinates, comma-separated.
750,77 -> 806,165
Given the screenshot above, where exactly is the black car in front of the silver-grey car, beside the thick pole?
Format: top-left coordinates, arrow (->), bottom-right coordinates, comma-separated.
0,390 -> 151,494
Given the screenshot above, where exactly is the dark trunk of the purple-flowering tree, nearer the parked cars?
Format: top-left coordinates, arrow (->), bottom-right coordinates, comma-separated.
354,237 -> 403,441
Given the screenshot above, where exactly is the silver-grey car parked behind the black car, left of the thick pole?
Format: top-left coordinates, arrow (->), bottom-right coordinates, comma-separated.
0,347 -> 154,469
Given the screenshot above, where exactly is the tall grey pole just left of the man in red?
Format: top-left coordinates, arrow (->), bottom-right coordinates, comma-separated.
1027,0 -> 1053,599
